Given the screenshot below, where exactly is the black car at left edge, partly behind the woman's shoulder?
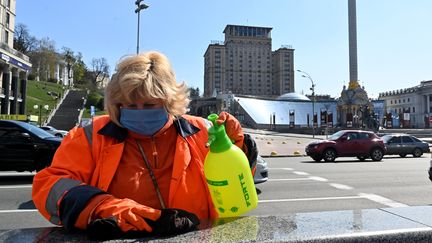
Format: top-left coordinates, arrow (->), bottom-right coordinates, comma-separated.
0,120 -> 62,172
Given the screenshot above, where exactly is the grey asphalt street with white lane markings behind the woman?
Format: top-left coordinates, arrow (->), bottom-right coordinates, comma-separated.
0,154 -> 432,230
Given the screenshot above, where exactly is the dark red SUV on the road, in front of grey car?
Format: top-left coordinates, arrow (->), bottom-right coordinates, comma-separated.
305,130 -> 386,162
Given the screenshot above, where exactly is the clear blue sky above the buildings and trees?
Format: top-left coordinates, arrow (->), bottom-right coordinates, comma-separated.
16,0 -> 432,97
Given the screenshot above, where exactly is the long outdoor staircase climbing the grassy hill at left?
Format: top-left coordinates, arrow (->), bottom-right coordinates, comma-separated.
48,90 -> 87,131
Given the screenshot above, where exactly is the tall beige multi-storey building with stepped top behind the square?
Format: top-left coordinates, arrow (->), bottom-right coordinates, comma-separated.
204,25 -> 294,97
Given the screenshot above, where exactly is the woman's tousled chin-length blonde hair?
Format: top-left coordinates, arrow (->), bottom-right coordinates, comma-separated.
105,51 -> 190,126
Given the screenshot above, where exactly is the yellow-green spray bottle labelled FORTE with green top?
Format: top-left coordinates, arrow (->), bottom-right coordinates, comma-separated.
204,114 -> 258,218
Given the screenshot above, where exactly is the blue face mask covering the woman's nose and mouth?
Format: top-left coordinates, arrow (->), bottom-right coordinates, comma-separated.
120,108 -> 168,136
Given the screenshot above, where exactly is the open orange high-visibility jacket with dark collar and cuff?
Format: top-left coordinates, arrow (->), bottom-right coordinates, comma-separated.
32,115 -> 217,229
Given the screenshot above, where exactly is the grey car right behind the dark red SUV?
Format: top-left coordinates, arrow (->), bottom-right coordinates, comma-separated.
382,134 -> 430,158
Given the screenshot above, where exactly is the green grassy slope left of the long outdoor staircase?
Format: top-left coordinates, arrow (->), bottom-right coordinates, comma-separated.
26,80 -> 64,119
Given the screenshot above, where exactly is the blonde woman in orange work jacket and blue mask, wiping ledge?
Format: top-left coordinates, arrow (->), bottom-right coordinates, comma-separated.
32,52 -> 256,237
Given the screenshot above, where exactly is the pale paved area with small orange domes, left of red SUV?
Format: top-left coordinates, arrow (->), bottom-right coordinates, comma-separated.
244,128 -> 325,157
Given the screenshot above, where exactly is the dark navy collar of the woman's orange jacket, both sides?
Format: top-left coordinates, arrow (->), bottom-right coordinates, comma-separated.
98,117 -> 200,142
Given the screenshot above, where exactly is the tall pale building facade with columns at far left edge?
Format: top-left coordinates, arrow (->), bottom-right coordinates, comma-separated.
0,0 -> 31,114
